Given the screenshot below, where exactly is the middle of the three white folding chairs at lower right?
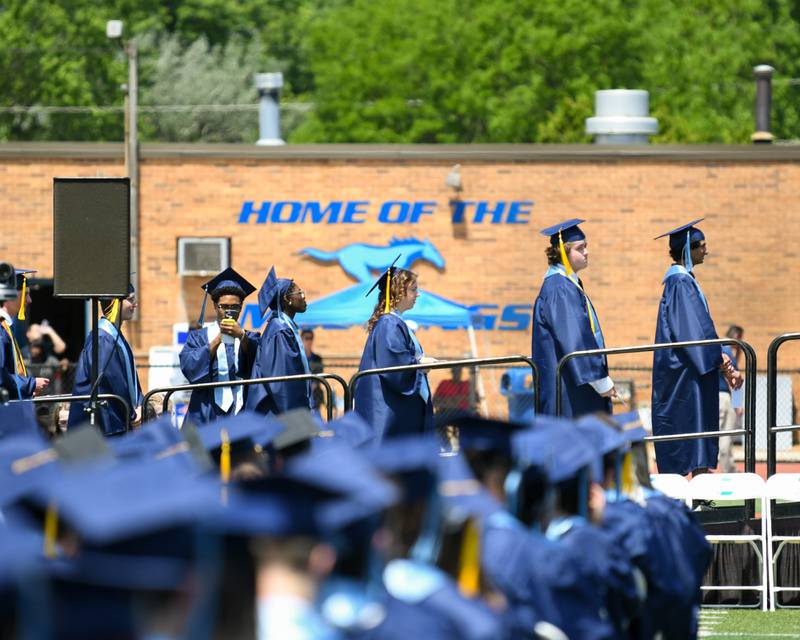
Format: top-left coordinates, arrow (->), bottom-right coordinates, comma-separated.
689,473 -> 769,611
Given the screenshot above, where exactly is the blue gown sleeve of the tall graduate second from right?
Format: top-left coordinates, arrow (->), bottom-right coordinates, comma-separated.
542,283 -> 608,385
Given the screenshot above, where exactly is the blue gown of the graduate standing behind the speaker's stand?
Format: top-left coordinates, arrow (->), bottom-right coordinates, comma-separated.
67,330 -> 143,436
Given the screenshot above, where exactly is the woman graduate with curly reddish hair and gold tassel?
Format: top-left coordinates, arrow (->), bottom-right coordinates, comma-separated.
354,260 -> 436,442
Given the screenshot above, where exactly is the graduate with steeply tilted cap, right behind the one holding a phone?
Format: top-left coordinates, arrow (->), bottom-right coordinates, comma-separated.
246,267 -> 313,415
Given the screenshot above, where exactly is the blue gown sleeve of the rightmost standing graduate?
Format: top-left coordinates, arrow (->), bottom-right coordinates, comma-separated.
664,277 -> 722,376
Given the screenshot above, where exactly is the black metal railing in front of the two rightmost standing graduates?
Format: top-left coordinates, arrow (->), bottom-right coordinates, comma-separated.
556,338 -> 756,473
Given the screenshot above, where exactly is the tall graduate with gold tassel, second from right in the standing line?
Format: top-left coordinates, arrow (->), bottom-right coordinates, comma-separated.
532,219 -> 616,417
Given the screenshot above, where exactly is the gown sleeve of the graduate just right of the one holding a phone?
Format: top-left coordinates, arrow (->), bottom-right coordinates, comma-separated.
261,327 -> 309,413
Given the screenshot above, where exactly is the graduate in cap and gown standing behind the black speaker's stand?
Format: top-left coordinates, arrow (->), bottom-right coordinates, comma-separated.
67,284 -> 143,436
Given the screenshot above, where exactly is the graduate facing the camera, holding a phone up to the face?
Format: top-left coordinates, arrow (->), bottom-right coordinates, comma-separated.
180,268 -> 259,425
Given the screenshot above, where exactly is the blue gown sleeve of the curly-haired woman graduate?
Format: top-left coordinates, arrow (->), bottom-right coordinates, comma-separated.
372,316 -> 424,396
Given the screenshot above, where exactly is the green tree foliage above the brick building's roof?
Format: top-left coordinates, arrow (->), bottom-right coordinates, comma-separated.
0,0 -> 800,143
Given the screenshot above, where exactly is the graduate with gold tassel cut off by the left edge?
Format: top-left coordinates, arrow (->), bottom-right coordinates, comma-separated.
0,269 -> 50,400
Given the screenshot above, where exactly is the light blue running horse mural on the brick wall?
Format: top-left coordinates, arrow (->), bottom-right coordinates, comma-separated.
299,238 -> 445,282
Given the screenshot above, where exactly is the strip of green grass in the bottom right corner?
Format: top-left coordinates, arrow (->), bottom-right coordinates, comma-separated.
698,609 -> 800,640
